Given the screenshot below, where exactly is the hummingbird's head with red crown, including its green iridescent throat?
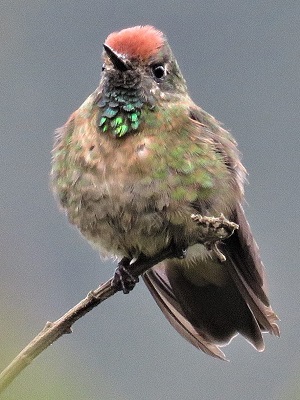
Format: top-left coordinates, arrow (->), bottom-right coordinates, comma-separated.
98,25 -> 187,137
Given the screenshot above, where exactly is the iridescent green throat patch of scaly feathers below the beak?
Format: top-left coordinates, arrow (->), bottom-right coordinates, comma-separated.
97,89 -> 144,137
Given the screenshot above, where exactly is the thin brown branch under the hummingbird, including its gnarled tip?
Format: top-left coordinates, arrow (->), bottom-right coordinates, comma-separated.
0,215 -> 238,393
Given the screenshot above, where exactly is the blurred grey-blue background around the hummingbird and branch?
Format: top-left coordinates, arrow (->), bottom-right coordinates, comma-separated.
0,0 -> 300,400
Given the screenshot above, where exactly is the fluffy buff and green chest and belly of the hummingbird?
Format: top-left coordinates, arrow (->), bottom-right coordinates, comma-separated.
54,104 -> 234,256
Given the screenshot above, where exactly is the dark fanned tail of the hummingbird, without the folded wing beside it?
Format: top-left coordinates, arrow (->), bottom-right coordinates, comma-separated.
144,262 -> 264,359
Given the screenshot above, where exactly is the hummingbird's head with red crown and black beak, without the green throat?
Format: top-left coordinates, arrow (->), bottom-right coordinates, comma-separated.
102,25 -> 186,97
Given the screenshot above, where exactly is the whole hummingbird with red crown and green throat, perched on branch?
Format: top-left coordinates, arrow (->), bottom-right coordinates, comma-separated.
51,25 -> 279,359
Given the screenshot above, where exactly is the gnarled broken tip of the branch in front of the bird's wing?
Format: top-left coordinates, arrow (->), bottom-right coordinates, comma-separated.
191,214 -> 239,262
